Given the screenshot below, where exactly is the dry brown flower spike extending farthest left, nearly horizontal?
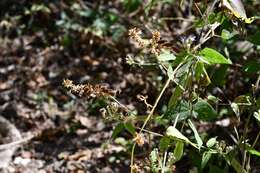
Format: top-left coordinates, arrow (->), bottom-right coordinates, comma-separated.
63,79 -> 115,97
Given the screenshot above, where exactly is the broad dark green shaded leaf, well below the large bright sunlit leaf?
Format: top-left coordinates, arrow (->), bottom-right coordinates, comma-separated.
194,99 -> 218,121
